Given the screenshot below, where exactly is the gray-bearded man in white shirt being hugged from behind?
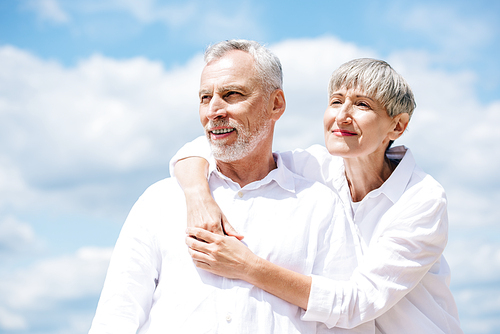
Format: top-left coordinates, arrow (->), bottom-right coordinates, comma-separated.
90,40 -> 366,334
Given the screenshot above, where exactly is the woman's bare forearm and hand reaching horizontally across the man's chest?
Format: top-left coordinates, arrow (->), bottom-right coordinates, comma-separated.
186,228 -> 312,310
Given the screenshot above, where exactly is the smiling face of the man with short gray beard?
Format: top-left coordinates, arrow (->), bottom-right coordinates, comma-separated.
199,51 -> 271,162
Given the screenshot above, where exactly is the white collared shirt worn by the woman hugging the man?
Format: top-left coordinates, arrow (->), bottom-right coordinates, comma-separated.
170,137 -> 462,334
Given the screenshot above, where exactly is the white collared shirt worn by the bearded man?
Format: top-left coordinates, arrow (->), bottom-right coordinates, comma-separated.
90,156 -> 356,334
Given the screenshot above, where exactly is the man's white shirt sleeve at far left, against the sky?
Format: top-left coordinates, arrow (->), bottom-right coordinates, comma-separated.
89,195 -> 160,334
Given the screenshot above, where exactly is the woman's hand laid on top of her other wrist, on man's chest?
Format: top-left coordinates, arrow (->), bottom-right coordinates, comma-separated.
186,227 -> 260,280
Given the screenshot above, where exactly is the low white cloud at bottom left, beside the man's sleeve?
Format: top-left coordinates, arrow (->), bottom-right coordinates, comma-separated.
0,247 -> 112,333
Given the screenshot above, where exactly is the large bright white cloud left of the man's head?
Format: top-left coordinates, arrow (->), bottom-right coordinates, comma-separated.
0,47 -> 202,215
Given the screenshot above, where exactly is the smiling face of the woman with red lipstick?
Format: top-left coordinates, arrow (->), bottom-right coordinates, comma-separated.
323,88 -> 406,158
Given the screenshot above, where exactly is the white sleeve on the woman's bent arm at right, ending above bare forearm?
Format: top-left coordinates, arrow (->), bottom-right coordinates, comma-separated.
303,185 -> 448,328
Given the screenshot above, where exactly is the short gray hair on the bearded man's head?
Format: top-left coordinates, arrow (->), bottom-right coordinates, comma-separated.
205,39 -> 283,93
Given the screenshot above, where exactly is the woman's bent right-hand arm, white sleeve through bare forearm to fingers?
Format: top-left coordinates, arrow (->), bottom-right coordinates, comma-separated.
186,189 -> 447,328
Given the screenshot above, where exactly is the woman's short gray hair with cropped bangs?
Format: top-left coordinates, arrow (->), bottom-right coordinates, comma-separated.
328,58 -> 416,117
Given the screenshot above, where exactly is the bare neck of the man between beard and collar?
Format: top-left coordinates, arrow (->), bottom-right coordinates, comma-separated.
216,151 -> 277,188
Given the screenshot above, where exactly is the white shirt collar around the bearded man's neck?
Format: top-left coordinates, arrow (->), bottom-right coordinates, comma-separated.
209,153 -> 295,193
